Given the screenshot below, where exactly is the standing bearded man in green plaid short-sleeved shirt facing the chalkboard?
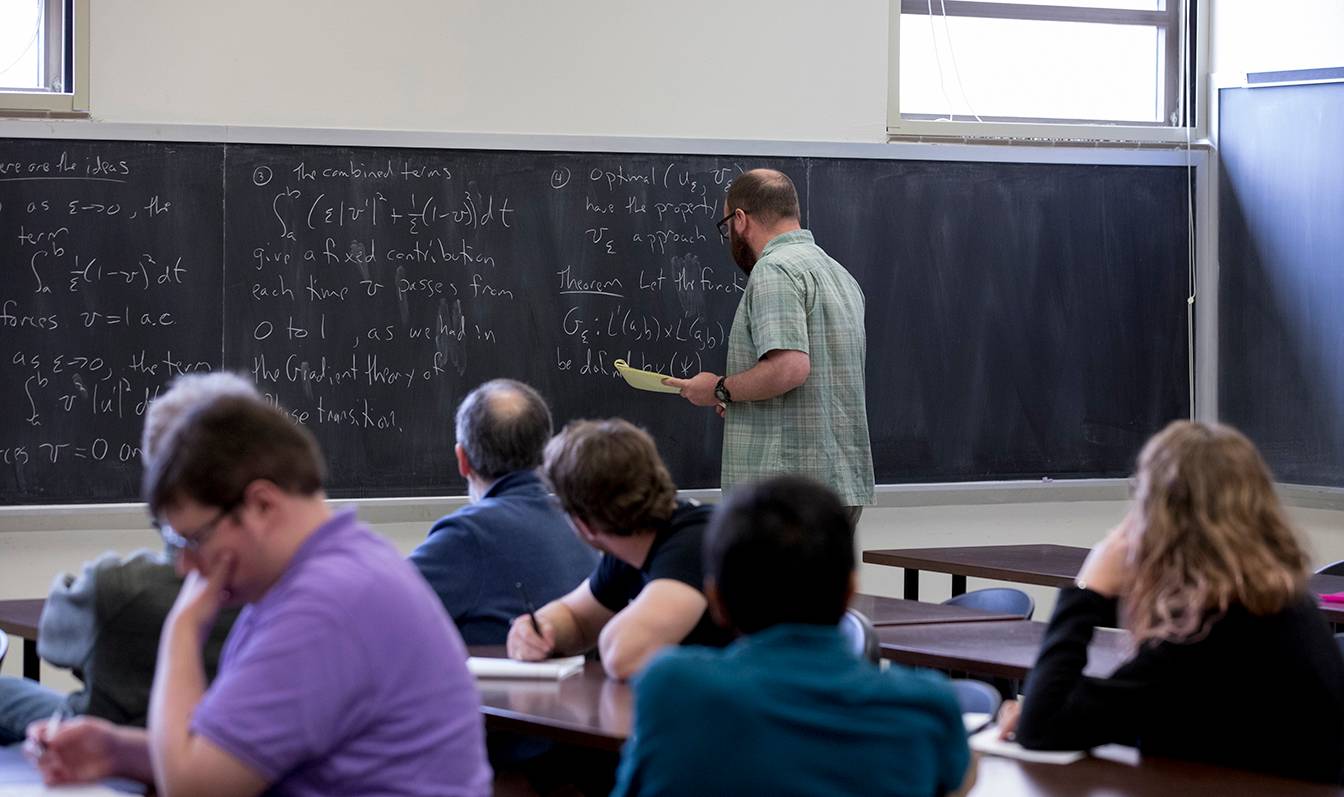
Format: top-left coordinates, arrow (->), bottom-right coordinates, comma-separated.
664,169 -> 874,523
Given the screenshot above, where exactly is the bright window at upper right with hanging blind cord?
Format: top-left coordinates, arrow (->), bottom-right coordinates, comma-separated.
890,0 -> 1195,140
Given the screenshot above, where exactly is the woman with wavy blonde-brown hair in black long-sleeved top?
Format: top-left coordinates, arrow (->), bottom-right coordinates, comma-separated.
1000,421 -> 1344,784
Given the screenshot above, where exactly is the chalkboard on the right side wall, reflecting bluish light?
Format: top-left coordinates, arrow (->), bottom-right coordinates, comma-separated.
1218,83 -> 1344,487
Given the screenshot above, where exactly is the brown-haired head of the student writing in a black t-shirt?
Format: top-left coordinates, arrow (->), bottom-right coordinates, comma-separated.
542,418 -> 676,536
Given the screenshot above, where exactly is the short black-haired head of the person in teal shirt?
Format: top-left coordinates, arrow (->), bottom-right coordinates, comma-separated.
703,476 -> 855,634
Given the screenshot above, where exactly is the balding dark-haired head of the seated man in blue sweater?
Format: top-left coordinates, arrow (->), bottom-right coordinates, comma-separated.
457,379 -> 551,480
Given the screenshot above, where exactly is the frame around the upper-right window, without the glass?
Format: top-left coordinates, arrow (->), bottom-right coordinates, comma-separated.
887,0 -> 1208,145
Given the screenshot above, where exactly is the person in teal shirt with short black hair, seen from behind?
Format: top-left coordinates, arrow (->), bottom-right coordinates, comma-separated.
613,476 -> 974,797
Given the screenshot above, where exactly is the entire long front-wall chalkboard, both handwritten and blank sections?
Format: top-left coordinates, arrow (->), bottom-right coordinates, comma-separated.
0,133 -> 1189,503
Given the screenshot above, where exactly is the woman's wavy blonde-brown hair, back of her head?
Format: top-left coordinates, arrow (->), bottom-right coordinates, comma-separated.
1125,421 -> 1308,642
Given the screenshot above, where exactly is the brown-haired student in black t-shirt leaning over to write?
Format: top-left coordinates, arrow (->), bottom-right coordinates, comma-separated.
508,418 -> 731,679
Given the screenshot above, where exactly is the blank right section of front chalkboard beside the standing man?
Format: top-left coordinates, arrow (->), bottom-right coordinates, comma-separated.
809,155 -> 1189,481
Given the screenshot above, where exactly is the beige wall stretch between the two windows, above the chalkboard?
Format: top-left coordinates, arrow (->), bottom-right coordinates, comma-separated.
90,0 -> 887,141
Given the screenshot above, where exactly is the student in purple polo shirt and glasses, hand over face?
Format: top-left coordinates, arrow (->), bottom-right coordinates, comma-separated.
30,398 -> 491,797
